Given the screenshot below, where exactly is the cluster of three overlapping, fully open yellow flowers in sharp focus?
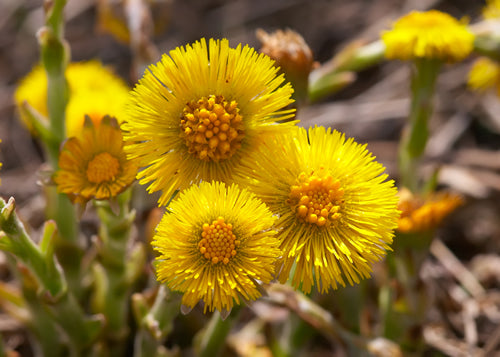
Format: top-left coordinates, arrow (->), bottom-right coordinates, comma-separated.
123,39 -> 399,311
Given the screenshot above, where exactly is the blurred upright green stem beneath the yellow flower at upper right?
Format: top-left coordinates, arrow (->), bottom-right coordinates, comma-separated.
399,58 -> 441,192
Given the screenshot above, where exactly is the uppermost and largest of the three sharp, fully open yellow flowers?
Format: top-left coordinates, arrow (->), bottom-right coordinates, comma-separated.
124,39 -> 293,205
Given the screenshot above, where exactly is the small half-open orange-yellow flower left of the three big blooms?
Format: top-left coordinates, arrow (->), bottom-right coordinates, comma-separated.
54,117 -> 137,204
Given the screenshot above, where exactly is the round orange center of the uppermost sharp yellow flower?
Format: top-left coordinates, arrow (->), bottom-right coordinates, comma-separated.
180,95 -> 244,161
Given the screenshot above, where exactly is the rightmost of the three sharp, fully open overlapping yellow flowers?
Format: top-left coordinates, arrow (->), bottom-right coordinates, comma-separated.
239,127 -> 399,292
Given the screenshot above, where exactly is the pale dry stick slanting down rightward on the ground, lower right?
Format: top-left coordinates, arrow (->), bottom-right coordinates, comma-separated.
430,239 -> 486,298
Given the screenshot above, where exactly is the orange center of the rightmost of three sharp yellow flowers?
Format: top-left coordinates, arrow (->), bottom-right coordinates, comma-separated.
287,173 -> 344,227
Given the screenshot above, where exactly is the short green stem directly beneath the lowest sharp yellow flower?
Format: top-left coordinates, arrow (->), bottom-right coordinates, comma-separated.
198,306 -> 242,357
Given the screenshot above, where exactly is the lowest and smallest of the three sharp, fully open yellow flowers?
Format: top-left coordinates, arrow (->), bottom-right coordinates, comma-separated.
153,182 -> 280,314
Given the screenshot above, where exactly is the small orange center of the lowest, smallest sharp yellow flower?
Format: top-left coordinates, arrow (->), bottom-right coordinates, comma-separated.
198,217 -> 240,264
